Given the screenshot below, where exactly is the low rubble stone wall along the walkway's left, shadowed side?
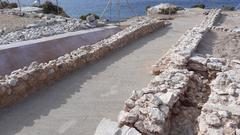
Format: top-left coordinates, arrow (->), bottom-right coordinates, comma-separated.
0,18 -> 166,107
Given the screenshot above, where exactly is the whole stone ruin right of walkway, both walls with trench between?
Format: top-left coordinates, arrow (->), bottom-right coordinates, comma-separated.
95,10 -> 240,135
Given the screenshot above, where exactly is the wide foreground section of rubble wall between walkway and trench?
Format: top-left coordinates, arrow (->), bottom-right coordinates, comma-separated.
119,69 -> 193,135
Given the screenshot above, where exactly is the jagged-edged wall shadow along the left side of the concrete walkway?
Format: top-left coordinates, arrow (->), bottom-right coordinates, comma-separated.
0,26 -> 172,135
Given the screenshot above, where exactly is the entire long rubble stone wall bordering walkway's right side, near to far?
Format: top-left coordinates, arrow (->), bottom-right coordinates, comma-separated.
118,10 -> 220,135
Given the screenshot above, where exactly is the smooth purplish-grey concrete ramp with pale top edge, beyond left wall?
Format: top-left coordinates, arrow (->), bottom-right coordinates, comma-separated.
0,26 -> 120,75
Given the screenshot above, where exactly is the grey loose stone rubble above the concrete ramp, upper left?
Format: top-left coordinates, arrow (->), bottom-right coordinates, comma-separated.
0,10 -> 103,45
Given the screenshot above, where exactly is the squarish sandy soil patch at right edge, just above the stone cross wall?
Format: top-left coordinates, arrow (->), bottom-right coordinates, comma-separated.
197,31 -> 240,59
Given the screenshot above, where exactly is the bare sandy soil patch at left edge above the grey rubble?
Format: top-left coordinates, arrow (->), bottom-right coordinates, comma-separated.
0,14 -> 37,32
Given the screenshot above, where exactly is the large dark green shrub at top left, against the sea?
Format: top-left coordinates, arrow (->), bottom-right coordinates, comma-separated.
40,1 -> 69,17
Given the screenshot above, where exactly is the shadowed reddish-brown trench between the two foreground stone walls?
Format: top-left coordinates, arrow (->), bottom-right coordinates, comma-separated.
170,72 -> 210,135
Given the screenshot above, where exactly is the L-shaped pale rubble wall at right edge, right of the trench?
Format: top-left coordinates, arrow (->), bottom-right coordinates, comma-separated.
189,56 -> 240,135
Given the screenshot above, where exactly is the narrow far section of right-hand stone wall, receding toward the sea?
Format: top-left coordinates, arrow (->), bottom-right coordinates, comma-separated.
152,10 -> 220,75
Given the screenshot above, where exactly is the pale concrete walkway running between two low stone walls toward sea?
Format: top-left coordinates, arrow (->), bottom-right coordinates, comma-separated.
0,12 -> 204,135
